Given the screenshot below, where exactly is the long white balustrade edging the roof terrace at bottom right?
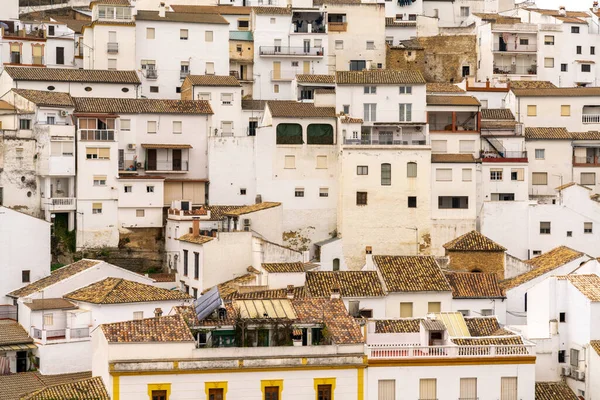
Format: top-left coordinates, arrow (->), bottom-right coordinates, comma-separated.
367,344 -> 534,359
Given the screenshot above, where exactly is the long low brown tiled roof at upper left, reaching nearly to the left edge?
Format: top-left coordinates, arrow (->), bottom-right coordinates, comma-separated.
4,67 -> 140,85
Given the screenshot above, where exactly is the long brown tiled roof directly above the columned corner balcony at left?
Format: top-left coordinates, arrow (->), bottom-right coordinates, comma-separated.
73,97 -> 213,114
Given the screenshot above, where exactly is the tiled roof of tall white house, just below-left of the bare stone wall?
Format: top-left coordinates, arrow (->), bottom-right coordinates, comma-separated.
335,69 -> 425,85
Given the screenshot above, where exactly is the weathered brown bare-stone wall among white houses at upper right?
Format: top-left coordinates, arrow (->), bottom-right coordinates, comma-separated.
386,35 -> 477,82
